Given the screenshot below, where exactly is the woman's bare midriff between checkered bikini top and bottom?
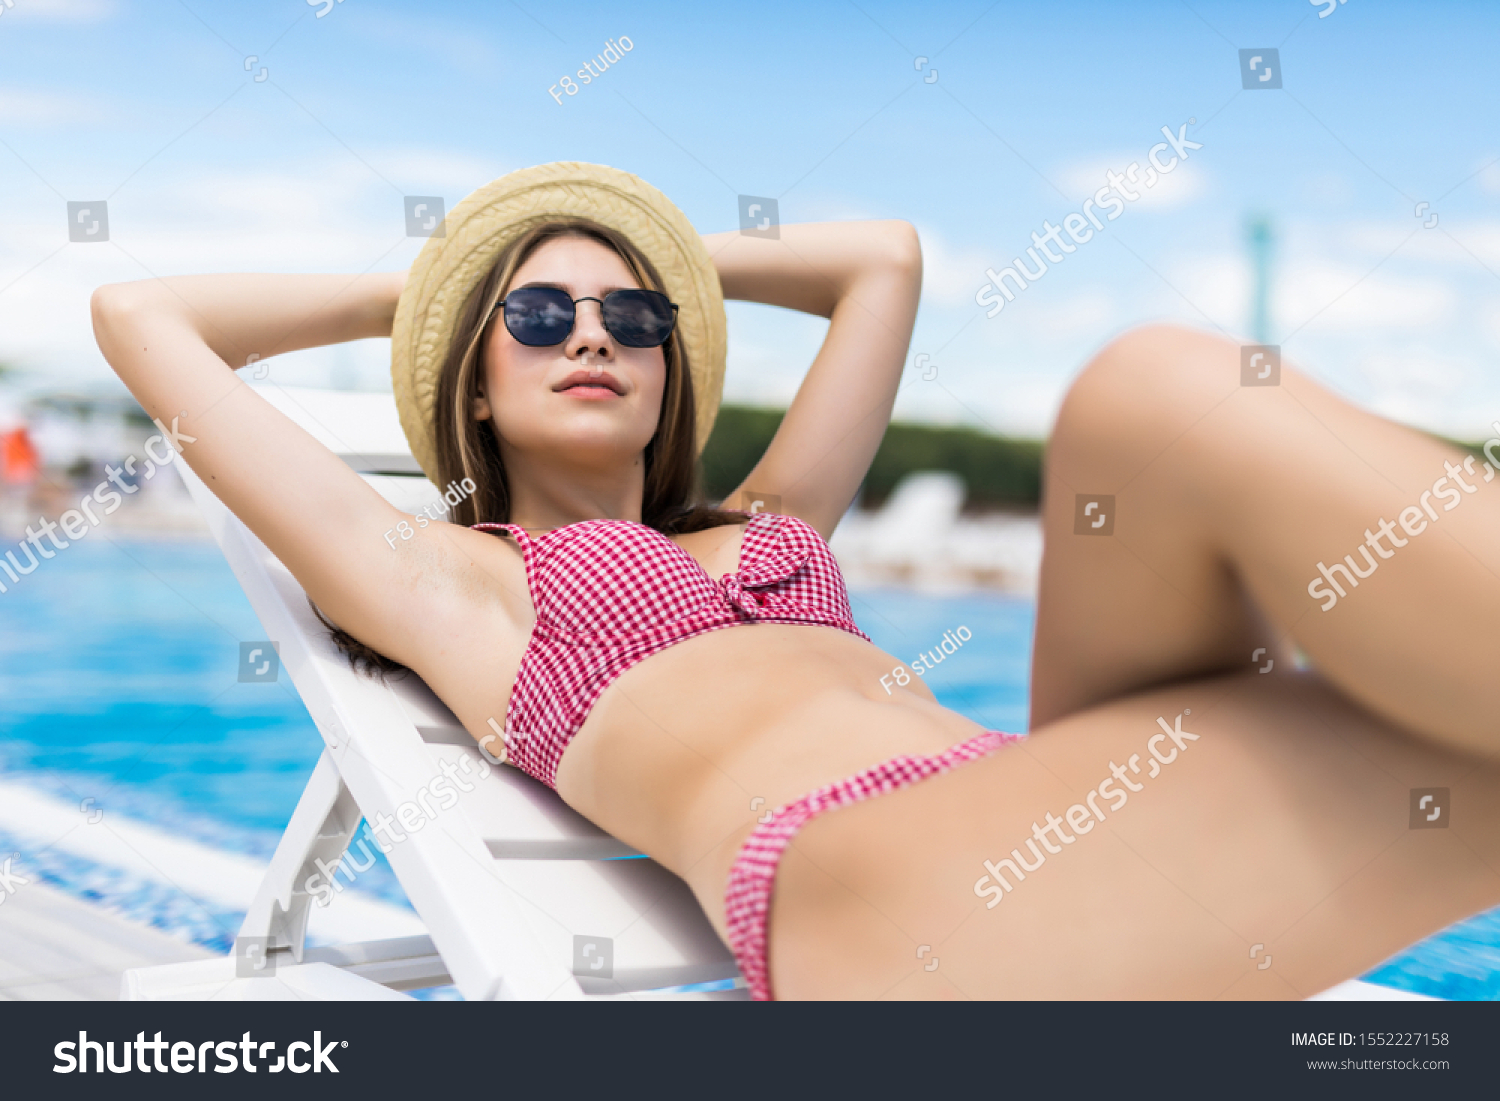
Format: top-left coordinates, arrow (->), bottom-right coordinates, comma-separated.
557,623 -> 983,933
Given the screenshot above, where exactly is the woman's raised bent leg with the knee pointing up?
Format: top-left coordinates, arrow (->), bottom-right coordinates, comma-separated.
1032,319 -> 1500,752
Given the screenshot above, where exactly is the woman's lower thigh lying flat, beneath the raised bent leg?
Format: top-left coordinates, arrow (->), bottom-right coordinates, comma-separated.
770,669 -> 1500,999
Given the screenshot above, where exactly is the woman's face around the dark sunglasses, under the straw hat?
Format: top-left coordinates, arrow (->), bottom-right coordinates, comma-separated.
474,237 -> 666,465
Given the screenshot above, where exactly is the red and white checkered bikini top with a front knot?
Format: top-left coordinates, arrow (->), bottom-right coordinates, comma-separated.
473,513 -> 869,788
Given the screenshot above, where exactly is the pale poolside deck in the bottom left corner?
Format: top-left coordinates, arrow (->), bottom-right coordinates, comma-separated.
0,881 -> 213,1002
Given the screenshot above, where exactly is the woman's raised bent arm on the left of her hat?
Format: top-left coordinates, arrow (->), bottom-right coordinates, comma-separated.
92,273 -> 456,663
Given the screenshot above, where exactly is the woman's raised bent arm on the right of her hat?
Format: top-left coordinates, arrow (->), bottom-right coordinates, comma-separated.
704,221 -> 923,539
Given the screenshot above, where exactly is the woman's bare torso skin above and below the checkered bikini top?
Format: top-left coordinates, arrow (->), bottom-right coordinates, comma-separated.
414,525 -> 983,933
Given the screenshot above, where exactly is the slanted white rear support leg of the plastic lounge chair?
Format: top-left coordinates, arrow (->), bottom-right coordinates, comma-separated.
236,750 -> 363,963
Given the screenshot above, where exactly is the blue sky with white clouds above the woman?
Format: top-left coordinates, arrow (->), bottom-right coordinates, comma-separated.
0,0 -> 1500,437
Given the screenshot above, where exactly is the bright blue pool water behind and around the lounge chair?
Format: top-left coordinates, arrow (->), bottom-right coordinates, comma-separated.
0,542 -> 1500,999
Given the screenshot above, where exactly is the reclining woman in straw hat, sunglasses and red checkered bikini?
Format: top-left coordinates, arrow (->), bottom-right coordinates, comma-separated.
93,164 -> 1500,998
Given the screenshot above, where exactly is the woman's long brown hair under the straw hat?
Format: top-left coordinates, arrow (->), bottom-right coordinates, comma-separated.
309,218 -> 744,678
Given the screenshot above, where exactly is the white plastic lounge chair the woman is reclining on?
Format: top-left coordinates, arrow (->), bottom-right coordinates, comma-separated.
122,387 -> 749,1001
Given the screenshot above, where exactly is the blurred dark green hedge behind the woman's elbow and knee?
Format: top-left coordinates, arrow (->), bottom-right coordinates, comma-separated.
702,405 -> 1044,509
